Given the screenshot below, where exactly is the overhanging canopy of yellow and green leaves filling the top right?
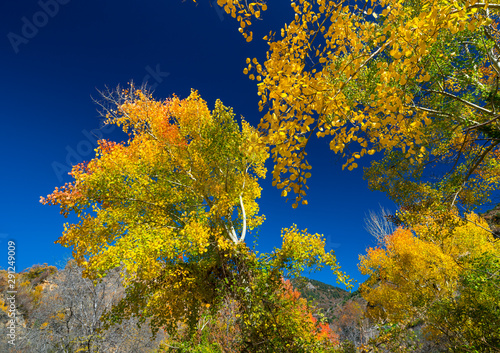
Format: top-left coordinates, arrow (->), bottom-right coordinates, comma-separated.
244,0 -> 500,207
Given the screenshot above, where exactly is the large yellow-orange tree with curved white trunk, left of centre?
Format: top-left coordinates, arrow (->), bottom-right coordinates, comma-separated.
42,87 -> 346,352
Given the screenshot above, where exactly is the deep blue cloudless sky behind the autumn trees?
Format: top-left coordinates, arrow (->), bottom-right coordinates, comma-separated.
0,0 -> 394,284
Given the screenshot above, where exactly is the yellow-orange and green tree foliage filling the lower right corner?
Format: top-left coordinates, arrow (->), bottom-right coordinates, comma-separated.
359,214 -> 500,352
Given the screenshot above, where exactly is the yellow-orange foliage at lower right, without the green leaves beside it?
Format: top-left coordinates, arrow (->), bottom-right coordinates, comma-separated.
359,214 -> 500,334
